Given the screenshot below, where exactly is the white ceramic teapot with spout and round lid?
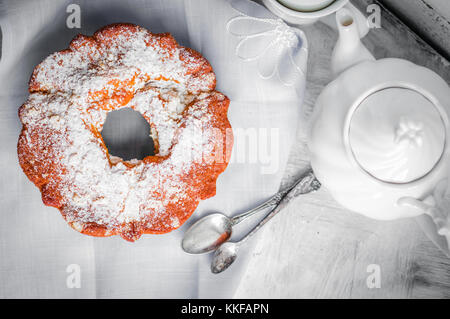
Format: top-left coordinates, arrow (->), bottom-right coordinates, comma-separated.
308,4 -> 450,238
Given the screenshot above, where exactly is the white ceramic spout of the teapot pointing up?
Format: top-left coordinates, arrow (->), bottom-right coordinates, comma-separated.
331,7 -> 375,77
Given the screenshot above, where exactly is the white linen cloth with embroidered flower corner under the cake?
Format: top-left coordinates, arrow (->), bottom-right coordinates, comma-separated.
0,0 -> 307,298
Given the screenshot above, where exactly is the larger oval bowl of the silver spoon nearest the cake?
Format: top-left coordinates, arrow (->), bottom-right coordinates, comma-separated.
181,213 -> 233,254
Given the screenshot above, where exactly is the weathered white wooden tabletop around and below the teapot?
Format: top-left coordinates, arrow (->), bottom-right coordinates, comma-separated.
235,0 -> 450,298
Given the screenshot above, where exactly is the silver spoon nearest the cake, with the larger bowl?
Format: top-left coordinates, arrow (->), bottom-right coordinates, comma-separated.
181,188 -> 291,254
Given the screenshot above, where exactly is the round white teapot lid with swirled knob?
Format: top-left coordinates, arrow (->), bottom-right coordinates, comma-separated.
348,87 -> 446,183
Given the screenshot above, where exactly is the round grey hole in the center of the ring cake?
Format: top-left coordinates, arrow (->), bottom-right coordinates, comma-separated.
101,107 -> 155,161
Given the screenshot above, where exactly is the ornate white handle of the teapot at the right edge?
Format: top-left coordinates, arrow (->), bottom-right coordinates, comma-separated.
398,180 -> 450,257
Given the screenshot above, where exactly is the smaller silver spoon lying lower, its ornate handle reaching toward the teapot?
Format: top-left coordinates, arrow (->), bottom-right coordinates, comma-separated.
211,170 -> 320,274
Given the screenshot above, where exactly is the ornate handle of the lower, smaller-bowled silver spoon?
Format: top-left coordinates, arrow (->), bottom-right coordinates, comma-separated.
237,170 -> 321,245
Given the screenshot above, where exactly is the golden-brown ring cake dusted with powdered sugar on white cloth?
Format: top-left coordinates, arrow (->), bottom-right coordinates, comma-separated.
18,24 -> 233,241
